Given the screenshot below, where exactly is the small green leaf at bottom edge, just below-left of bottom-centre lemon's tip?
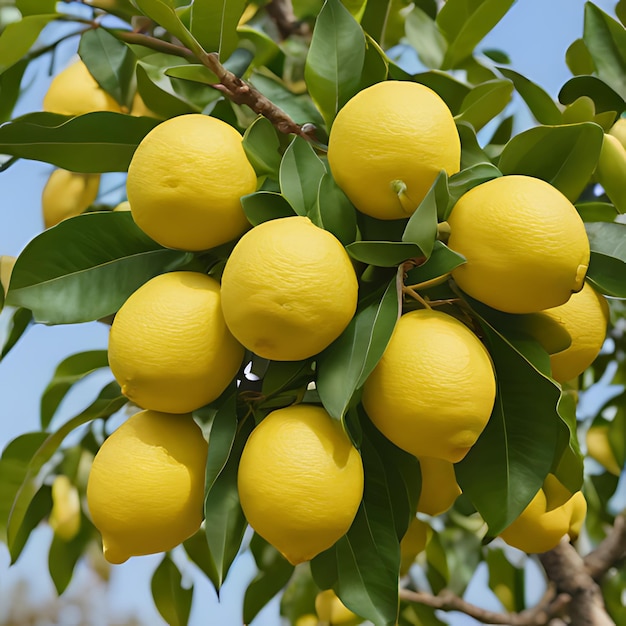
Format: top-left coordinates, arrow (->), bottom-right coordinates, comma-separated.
243,533 -> 294,624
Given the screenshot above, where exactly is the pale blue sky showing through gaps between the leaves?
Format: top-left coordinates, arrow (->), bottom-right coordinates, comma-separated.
0,0 -> 615,626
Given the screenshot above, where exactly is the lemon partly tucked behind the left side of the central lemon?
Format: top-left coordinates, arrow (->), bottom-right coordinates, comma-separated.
108,271 -> 244,413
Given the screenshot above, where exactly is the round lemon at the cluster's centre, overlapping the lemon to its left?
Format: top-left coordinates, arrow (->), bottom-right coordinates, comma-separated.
222,216 -> 358,361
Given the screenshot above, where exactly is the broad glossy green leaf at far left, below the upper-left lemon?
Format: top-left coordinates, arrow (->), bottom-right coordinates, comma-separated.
7,211 -> 192,324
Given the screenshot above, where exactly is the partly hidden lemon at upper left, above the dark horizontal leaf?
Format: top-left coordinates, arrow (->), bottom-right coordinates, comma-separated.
43,60 -> 122,115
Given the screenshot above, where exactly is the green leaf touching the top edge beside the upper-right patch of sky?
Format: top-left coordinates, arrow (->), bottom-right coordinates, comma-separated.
437,0 -> 515,69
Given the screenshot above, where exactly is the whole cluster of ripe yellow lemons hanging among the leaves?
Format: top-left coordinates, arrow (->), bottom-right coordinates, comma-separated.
36,59 -> 608,584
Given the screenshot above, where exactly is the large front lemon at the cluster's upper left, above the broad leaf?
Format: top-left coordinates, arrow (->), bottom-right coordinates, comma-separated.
126,113 -> 256,251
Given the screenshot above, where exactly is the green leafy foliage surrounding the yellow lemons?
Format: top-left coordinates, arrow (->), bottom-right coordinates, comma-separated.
0,0 -> 626,626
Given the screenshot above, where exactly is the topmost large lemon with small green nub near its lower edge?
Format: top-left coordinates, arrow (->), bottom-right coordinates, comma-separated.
328,80 -> 461,220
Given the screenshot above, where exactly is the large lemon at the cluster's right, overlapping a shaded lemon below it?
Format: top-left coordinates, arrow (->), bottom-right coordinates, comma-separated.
448,175 -> 590,313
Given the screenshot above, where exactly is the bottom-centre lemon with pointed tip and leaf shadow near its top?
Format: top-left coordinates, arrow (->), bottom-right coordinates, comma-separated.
238,404 -> 363,565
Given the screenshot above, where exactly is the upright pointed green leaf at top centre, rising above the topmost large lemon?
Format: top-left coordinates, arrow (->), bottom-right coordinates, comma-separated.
304,0 -> 365,128
